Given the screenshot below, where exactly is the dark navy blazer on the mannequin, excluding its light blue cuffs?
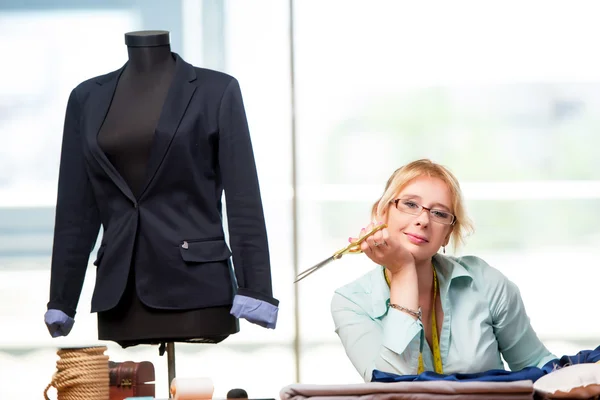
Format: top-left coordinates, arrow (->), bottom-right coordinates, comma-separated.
48,54 -> 278,317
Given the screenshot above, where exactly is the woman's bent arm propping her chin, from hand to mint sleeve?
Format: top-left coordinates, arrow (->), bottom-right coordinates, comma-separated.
331,223 -> 424,382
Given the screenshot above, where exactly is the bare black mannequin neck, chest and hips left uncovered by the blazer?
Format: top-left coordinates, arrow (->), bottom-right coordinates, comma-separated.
98,31 -> 239,347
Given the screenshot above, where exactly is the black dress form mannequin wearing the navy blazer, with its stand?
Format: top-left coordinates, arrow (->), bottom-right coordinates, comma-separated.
44,31 -> 279,396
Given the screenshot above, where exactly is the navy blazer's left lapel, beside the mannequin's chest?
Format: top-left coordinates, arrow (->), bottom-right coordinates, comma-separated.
86,64 -> 136,202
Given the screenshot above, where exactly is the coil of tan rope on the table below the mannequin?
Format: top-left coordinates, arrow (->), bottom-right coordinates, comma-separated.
44,346 -> 109,400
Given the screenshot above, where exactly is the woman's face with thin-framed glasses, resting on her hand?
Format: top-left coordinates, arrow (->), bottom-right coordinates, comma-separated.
386,176 -> 454,262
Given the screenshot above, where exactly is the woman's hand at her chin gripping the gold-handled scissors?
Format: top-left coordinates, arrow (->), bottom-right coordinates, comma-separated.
348,222 -> 415,275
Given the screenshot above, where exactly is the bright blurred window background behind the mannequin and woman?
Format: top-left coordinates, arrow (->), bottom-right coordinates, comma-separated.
0,0 -> 600,399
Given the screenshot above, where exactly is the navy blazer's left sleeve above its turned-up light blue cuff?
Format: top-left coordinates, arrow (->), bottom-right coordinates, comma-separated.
48,90 -> 100,318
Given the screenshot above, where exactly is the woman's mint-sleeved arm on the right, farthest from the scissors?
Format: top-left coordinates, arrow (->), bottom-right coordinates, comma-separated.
487,268 -> 555,371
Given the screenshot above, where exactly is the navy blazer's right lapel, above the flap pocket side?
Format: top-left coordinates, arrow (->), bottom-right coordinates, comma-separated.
140,53 -> 196,198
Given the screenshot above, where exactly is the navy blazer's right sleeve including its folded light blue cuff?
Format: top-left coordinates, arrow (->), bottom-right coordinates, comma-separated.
219,78 -> 279,327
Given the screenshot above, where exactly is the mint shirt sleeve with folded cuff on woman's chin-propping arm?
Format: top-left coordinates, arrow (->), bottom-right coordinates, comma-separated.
331,291 -> 423,382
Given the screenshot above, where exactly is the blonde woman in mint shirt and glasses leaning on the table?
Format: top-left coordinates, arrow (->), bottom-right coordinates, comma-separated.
331,160 -> 555,382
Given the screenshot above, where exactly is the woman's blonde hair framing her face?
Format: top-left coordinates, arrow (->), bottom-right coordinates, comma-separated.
371,159 -> 473,250
